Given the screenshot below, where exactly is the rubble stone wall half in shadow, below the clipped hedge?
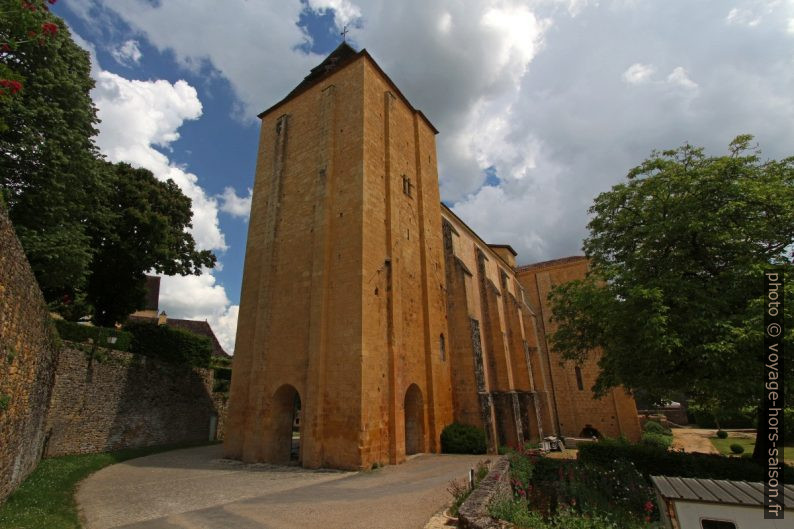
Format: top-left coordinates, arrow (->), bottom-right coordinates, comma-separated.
46,342 -> 223,456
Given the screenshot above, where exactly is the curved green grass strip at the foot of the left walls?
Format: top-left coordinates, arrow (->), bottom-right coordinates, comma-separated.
0,443 -> 217,529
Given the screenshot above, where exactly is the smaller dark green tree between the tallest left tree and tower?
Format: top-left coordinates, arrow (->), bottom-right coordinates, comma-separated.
86,163 -> 215,325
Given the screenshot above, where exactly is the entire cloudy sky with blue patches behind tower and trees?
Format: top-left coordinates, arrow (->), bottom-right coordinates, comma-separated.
54,0 -> 794,351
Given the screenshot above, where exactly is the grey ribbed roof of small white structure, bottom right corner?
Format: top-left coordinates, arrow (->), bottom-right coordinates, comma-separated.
651,476 -> 794,508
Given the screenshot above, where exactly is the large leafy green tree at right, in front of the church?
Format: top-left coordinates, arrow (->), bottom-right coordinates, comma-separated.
551,135 -> 794,462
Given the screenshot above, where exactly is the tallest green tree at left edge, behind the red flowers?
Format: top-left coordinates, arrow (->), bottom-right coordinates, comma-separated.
0,6 -> 105,300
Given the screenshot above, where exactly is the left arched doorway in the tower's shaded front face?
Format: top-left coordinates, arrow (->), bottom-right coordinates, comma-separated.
271,384 -> 301,465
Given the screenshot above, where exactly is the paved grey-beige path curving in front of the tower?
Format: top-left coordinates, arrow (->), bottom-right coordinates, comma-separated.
77,445 -> 487,529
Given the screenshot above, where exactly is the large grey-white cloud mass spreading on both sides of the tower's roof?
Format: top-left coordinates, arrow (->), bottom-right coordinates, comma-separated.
64,0 -> 794,263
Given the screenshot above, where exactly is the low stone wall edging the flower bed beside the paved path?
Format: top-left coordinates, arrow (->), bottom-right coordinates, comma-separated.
458,457 -> 513,529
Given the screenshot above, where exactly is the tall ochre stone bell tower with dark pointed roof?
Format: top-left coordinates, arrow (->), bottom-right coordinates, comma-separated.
224,43 -> 453,469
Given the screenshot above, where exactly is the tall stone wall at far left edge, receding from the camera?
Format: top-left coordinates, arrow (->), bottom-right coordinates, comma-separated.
0,205 -> 58,503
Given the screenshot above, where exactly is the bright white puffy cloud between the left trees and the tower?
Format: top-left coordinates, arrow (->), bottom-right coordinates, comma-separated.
75,27 -> 237,353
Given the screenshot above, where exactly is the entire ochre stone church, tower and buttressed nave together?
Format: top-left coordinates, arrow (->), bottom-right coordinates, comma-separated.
224,43 -> 640,469
